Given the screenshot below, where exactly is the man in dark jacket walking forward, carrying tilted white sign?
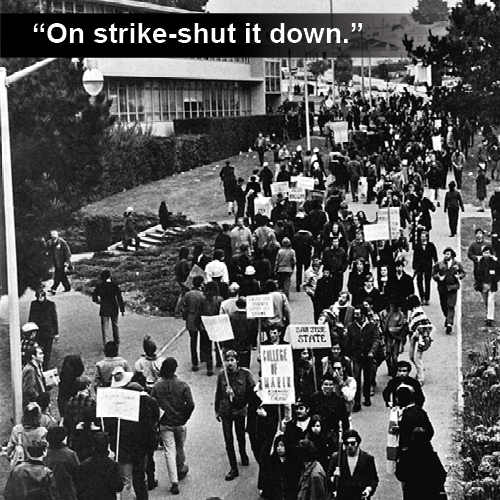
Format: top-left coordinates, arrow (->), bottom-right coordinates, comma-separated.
215,350 -> 255,481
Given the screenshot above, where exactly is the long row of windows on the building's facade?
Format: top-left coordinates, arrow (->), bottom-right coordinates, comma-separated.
106,80 -> 252,122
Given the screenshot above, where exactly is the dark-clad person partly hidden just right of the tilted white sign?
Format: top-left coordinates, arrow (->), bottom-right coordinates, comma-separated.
227,296 -> 258,368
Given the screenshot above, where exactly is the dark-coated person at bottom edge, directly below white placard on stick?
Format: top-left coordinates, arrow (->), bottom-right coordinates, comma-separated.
76,432 -> 123,500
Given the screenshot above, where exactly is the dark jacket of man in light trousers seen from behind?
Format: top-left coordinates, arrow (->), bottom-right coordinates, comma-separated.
151,375 -> 194,427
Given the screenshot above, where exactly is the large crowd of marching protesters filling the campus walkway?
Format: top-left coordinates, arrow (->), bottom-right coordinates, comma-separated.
5,89 -> 500,500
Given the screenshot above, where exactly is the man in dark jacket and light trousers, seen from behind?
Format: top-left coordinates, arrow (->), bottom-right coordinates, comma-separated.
151,357 -> 195,495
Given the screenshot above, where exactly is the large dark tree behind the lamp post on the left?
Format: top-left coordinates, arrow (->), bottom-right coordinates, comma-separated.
0,58 -> 112,294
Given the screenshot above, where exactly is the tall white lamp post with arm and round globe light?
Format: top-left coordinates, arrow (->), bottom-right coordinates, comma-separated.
0,57 -> 103,424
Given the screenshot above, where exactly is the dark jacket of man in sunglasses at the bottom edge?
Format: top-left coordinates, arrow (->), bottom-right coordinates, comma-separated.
328,450 -> 378,500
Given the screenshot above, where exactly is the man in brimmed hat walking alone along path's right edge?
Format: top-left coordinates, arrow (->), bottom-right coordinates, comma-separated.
432,247 -> 465,333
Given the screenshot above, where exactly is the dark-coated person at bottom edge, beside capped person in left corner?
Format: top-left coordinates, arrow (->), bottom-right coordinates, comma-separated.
43,427 -> 80,500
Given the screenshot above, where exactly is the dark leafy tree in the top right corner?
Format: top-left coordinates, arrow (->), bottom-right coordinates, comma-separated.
404,0 -> 500,121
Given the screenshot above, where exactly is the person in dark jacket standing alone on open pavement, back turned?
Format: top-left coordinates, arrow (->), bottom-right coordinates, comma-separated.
92,269 -> 125,346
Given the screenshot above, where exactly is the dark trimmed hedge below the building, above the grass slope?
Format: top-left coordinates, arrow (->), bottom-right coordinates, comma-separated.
174,115 -> 284,163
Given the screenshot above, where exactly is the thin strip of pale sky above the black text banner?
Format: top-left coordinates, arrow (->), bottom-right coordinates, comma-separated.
207,0 -> 457,14
